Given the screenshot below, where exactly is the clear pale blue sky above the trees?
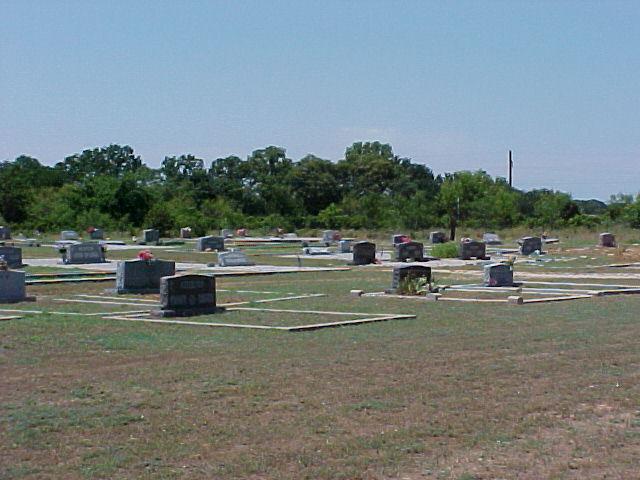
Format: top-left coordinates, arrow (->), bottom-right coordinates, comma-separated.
0,0 -> 640,200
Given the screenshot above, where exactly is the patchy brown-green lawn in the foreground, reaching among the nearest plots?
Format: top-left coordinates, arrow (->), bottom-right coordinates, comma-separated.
0,268 -> 640,480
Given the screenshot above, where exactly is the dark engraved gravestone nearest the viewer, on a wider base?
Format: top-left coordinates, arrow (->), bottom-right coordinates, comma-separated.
151,275 -> 222,317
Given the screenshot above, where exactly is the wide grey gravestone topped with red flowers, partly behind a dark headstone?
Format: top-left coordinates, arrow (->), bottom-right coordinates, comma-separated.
116,259 -> 176,293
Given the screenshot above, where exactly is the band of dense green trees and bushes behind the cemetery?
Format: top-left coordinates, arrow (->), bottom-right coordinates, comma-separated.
0,142 -> 640,239
